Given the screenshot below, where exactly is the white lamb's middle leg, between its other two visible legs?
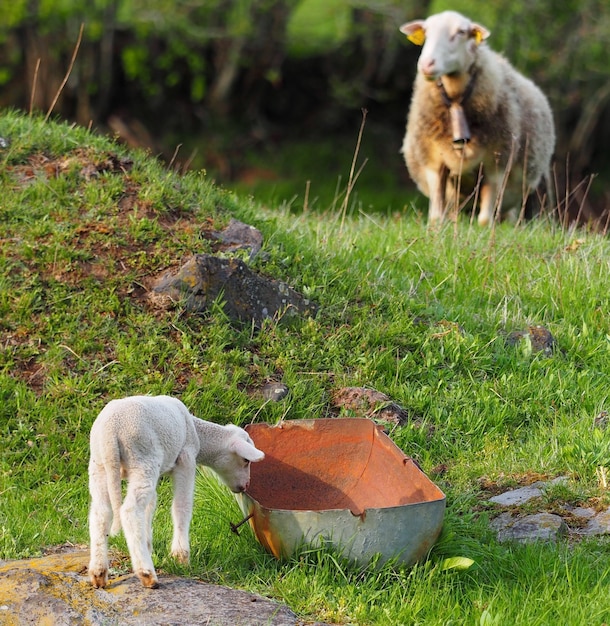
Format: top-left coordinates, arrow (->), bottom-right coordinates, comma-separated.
121,471 -> 159,589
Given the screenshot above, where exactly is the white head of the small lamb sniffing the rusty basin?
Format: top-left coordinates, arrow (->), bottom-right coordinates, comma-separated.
213,424 -> 265,493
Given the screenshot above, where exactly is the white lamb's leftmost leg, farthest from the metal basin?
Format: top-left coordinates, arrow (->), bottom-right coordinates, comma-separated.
89,462 -> 112,588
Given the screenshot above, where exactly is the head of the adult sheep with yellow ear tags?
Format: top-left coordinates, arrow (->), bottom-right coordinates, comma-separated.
400,11 -> 490,80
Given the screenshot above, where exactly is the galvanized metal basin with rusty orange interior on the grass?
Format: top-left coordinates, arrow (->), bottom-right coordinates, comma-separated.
236,418 -> 445,564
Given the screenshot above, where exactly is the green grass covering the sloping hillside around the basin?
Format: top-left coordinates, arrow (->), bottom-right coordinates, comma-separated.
0,112 -> 610,626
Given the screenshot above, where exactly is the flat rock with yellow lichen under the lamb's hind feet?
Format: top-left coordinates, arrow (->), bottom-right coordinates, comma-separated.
0,550 -> 300,626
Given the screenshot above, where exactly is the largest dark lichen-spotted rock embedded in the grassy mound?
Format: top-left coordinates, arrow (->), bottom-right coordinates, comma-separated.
150,254 -> 317,328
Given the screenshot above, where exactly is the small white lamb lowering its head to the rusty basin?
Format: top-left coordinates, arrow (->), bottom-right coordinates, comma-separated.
89,396 -> 265,588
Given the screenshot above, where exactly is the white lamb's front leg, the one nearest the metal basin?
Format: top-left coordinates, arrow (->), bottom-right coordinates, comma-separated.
172,453 -> 196,565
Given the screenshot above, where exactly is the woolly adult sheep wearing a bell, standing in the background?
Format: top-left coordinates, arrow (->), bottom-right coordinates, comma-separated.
400,11 -> 555,225
